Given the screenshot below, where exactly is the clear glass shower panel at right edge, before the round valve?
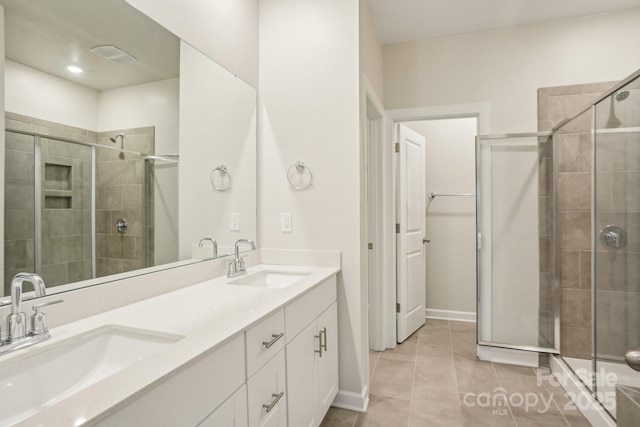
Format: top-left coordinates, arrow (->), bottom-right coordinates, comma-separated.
593,83 -> 640,417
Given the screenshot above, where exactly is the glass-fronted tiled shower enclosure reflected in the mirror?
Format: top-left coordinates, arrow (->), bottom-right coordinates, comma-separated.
4,113 -> 154,295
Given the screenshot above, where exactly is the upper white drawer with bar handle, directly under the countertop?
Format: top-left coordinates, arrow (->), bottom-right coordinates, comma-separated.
245,309 -> 285,378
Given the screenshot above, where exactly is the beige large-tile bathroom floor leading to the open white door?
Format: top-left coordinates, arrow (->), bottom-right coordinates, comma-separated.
321,320 -> 591,427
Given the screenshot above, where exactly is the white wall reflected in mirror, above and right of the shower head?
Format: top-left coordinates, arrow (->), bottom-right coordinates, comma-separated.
97,79 -> 180,265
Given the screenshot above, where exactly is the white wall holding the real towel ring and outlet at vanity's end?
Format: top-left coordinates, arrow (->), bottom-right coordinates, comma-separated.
258,0 -> 368,408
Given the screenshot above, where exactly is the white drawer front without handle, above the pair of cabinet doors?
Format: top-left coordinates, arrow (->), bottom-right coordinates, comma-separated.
284,275 -> 336,342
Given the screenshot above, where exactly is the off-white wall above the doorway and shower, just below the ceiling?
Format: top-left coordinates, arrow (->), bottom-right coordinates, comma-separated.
384,9 -> 640,133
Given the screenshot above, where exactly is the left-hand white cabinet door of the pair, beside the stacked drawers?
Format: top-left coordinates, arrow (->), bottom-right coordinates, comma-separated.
286,322 -> 320,427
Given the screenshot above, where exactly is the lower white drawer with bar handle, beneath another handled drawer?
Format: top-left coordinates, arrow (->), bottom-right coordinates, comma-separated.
247,350 -> 287,427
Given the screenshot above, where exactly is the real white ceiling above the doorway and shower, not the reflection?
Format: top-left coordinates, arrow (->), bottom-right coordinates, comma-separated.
369,0 -> 640,44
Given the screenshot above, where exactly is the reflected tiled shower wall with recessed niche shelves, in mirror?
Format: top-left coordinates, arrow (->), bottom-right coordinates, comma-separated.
4,112 -> 97,295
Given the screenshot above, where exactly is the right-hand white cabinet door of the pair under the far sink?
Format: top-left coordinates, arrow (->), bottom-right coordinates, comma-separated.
317,302 -> 338,419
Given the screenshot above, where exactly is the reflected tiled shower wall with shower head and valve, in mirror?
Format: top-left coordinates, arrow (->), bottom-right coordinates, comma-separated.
96,127 -> 155,276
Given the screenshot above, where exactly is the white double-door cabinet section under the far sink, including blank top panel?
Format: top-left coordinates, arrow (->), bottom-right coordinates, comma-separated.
285,278 -> 338,427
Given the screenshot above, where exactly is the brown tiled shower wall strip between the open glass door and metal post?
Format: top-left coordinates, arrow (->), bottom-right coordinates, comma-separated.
538,83 -> 611,359
